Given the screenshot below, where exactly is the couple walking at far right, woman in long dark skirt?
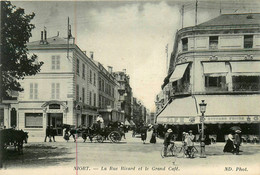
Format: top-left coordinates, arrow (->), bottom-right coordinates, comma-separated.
223,130 -> 241,155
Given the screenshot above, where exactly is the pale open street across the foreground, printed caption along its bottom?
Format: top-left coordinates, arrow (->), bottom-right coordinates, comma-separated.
0,132 -> 260,175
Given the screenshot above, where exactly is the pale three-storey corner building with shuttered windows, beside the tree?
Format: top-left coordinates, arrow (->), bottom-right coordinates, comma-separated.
18,31 -> 98,136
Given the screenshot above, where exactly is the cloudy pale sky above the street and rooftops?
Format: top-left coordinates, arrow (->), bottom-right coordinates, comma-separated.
11,0 -> 260,111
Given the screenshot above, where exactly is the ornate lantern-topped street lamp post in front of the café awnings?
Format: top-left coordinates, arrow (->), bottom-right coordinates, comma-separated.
199,100 -> 207,158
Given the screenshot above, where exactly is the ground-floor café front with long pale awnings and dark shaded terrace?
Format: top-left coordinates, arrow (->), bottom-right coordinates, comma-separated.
157,95 -> 260,141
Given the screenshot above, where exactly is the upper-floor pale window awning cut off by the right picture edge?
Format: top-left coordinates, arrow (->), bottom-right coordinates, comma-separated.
230,61 -> 260,75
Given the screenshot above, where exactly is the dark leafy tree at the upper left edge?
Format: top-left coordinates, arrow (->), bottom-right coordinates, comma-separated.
0,1 -> 43,98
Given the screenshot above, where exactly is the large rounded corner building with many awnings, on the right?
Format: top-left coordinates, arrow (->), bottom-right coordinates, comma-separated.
157,13 -> 260,140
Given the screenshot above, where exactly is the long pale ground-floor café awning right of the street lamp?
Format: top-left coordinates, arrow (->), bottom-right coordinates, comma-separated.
195,95 -> 260,124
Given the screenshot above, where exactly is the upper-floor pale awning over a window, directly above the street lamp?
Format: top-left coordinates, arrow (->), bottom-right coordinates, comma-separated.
203,62 -> 228,76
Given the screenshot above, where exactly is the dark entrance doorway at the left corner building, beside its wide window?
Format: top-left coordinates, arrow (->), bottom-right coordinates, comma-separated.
48,113 -> 63,136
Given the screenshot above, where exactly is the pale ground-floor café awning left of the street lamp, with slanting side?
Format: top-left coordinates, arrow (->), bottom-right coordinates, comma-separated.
157,97 -> 199,125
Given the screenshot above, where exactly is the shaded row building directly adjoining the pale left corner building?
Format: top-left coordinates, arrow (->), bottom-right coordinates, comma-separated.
96,62 -> 124,125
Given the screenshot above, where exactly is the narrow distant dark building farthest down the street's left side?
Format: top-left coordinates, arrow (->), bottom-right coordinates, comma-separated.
113,69 -> 133,120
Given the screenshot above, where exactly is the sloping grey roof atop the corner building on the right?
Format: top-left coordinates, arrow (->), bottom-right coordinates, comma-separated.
197,13 -> 260,26
